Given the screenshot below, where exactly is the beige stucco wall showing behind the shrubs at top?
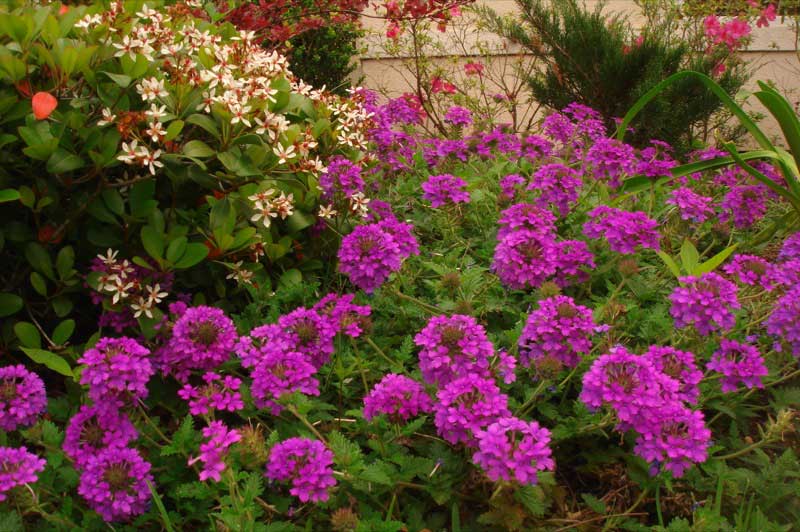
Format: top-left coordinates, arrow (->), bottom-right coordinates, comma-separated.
356,0 -> 800,139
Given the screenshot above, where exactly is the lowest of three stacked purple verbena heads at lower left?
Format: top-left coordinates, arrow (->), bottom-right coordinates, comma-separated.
78,447 -> 153,522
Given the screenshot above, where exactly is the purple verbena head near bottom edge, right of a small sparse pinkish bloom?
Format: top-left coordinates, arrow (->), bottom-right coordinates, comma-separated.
266,438 -> 336,502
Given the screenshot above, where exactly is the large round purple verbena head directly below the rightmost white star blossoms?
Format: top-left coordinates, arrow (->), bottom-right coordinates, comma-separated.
339,224 -> 404,294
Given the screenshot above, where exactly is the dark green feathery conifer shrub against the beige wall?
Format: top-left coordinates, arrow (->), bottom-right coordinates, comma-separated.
486,0 -> 746,152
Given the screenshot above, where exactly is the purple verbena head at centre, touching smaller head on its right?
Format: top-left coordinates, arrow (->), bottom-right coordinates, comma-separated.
492,229 -> 559,290
